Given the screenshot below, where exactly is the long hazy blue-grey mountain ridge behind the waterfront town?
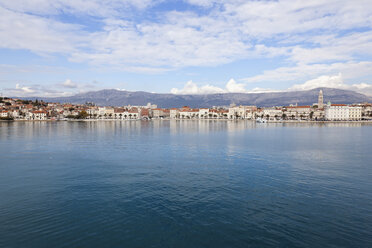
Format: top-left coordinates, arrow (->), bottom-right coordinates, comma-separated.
21,88 -> 372,108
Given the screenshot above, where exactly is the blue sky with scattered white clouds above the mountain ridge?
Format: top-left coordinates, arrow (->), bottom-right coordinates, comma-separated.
0,0 -> 372,97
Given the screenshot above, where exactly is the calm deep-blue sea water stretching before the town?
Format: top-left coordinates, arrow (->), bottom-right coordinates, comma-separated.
0,121 -> 372,248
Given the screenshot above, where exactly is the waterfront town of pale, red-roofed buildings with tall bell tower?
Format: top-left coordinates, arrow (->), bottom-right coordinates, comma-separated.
0,91 -> 372,122
